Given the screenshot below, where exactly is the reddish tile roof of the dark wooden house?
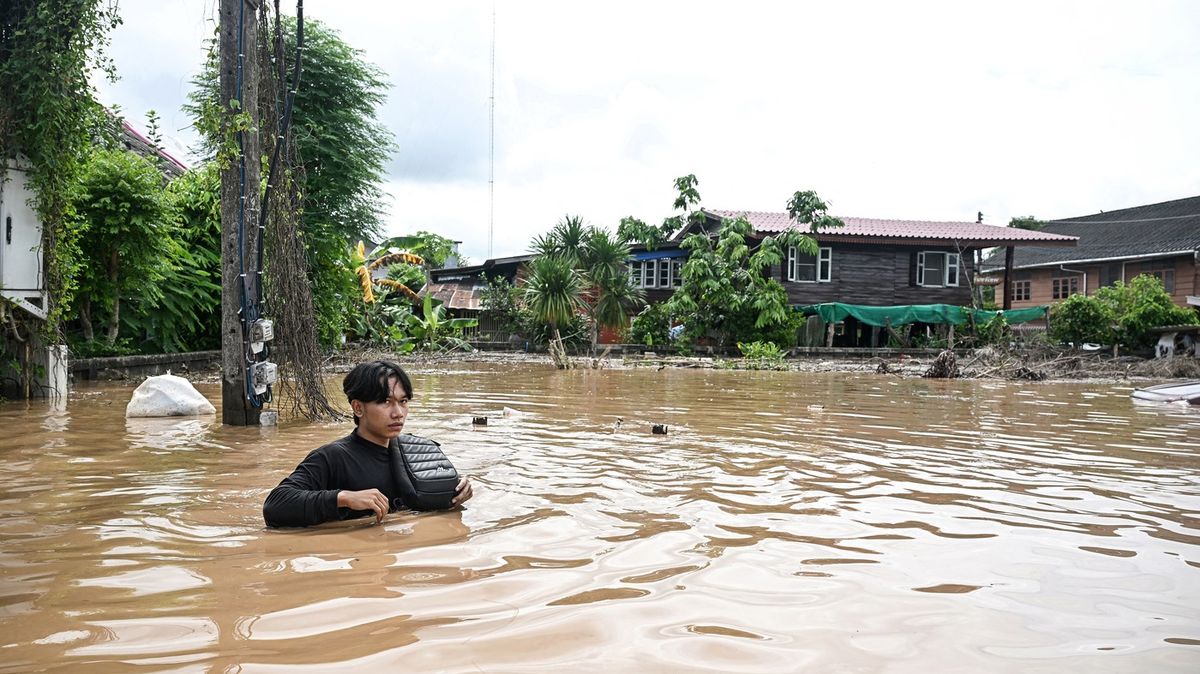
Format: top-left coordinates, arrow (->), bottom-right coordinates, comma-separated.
704,209 -> 1079,246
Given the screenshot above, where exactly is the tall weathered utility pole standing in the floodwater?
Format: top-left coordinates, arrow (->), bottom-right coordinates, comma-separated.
220,0 -> 260,426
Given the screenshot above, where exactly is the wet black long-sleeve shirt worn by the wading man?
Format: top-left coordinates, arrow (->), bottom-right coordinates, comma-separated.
263,432 -> 401,526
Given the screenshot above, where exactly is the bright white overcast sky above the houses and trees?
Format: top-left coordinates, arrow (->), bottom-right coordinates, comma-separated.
98,0 -> 1200,263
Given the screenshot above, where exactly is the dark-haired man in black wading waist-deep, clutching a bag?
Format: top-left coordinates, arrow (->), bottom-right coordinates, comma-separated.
263,361 -> 473,526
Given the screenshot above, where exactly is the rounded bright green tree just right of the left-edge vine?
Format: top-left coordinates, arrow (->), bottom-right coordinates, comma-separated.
74,149 -> 173,347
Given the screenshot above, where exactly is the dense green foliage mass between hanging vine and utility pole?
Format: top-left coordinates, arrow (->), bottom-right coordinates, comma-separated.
71,148 -> 221,355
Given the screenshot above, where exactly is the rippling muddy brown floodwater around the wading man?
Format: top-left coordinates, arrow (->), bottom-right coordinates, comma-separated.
0,363 -> 1200,673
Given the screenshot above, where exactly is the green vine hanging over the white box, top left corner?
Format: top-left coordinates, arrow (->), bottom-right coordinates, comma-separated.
0,0 -> 121,342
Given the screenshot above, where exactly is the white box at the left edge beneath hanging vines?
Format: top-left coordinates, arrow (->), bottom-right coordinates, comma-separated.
0,160 -> 46,318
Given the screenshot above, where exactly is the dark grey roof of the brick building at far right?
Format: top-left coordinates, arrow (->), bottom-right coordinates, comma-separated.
984,197 -> 1200,269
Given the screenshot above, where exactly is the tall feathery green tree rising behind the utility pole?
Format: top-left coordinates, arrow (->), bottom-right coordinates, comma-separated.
185,17 -> 395,344
